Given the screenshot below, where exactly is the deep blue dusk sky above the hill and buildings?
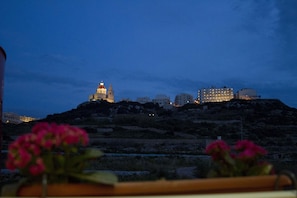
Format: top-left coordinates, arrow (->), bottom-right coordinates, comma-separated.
0,0 -> 297,118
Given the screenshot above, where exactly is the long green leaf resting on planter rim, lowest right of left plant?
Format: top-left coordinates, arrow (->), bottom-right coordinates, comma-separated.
69,172 -> 118,185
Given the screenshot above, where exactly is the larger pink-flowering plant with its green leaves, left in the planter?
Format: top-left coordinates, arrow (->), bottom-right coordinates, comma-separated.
4,122 -> 117,196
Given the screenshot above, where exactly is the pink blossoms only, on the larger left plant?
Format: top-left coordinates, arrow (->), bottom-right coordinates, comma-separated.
6,123 -> 89,176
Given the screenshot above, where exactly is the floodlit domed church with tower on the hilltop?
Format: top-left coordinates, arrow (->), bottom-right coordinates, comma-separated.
89,81 -> 114,103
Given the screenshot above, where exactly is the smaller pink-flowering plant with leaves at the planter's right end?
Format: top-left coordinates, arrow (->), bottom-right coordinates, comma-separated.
206,140 -> 272,177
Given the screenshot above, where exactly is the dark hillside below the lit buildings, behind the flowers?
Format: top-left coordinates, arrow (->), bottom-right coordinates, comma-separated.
3,99 -> 297,181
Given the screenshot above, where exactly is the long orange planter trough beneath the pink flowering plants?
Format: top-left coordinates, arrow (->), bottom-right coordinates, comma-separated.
18,175 -> 292,196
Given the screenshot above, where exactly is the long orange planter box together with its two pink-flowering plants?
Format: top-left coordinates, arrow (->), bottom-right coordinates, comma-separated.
1,123 -> 293,196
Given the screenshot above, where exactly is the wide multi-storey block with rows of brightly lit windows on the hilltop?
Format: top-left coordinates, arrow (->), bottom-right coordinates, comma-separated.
198,87 -> 234,104
